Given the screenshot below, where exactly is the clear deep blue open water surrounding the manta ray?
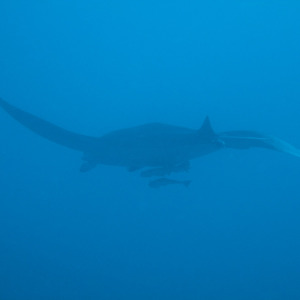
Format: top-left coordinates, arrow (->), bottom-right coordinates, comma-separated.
0,0 -> 300,300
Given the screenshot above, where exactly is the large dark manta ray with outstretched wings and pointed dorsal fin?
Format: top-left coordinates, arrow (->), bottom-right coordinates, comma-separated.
0,98 -> 300,186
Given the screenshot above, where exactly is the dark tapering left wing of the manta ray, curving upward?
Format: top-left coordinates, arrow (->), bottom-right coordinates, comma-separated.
0,98 -> 97,152
